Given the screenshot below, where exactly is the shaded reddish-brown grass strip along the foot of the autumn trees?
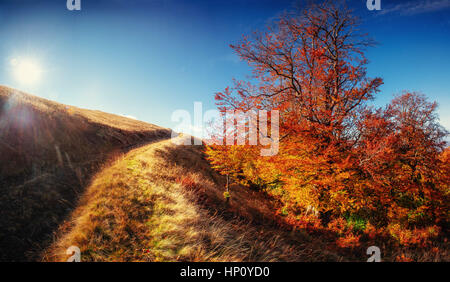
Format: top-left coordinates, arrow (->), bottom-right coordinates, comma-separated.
153,145 -> 448,262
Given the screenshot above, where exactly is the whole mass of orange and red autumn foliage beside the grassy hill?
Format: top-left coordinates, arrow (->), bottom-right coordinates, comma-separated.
206,2 -> 450,246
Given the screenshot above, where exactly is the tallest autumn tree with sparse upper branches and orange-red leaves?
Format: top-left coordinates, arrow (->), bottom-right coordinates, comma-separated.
209,2 -> 382,217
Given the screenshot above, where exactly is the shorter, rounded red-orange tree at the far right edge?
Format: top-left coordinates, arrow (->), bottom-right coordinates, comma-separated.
357,92 -> 450,226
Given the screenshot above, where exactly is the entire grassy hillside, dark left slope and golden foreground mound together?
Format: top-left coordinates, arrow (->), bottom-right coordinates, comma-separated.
0,87 -> 448,261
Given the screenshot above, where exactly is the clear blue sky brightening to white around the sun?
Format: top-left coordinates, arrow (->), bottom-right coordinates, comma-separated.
0,0 -> 450,134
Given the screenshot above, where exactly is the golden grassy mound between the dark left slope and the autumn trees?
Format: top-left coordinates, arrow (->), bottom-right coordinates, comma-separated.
44,137 -> 344,261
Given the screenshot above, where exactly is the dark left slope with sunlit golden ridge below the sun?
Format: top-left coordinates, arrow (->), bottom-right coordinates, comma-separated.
0,87 -> 170,261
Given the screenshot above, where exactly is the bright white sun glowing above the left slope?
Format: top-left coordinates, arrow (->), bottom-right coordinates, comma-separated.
10,58 -> 42,85
